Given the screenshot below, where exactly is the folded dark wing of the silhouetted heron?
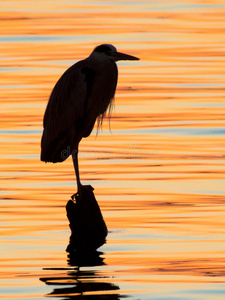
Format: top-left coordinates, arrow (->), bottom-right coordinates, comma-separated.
41,61 -> 94,161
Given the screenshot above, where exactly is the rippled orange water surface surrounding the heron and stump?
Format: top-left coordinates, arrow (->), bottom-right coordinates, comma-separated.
0,0 -> 225,300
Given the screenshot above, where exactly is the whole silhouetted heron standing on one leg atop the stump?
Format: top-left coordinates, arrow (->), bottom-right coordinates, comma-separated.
41,44 -> 138,193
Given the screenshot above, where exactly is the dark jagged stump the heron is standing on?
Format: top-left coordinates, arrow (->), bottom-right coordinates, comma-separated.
66,185 -> 108,252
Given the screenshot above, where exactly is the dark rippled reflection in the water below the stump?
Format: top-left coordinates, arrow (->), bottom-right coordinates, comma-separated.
40,251 -> 122,300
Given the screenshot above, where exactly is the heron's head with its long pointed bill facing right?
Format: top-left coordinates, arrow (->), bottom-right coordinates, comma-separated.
90,44 -> 139,62
